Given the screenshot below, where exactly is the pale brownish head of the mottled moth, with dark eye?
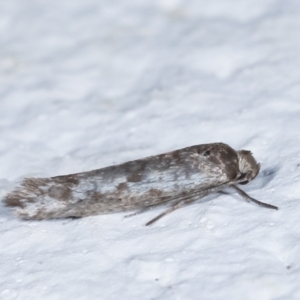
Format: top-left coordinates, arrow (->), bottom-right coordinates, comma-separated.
237,150 -> 260,184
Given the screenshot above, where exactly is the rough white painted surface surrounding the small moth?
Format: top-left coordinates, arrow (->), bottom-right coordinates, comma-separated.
0,0 -> 300,300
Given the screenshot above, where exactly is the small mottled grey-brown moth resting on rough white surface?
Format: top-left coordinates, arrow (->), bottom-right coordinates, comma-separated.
4,143 -> 278,225
